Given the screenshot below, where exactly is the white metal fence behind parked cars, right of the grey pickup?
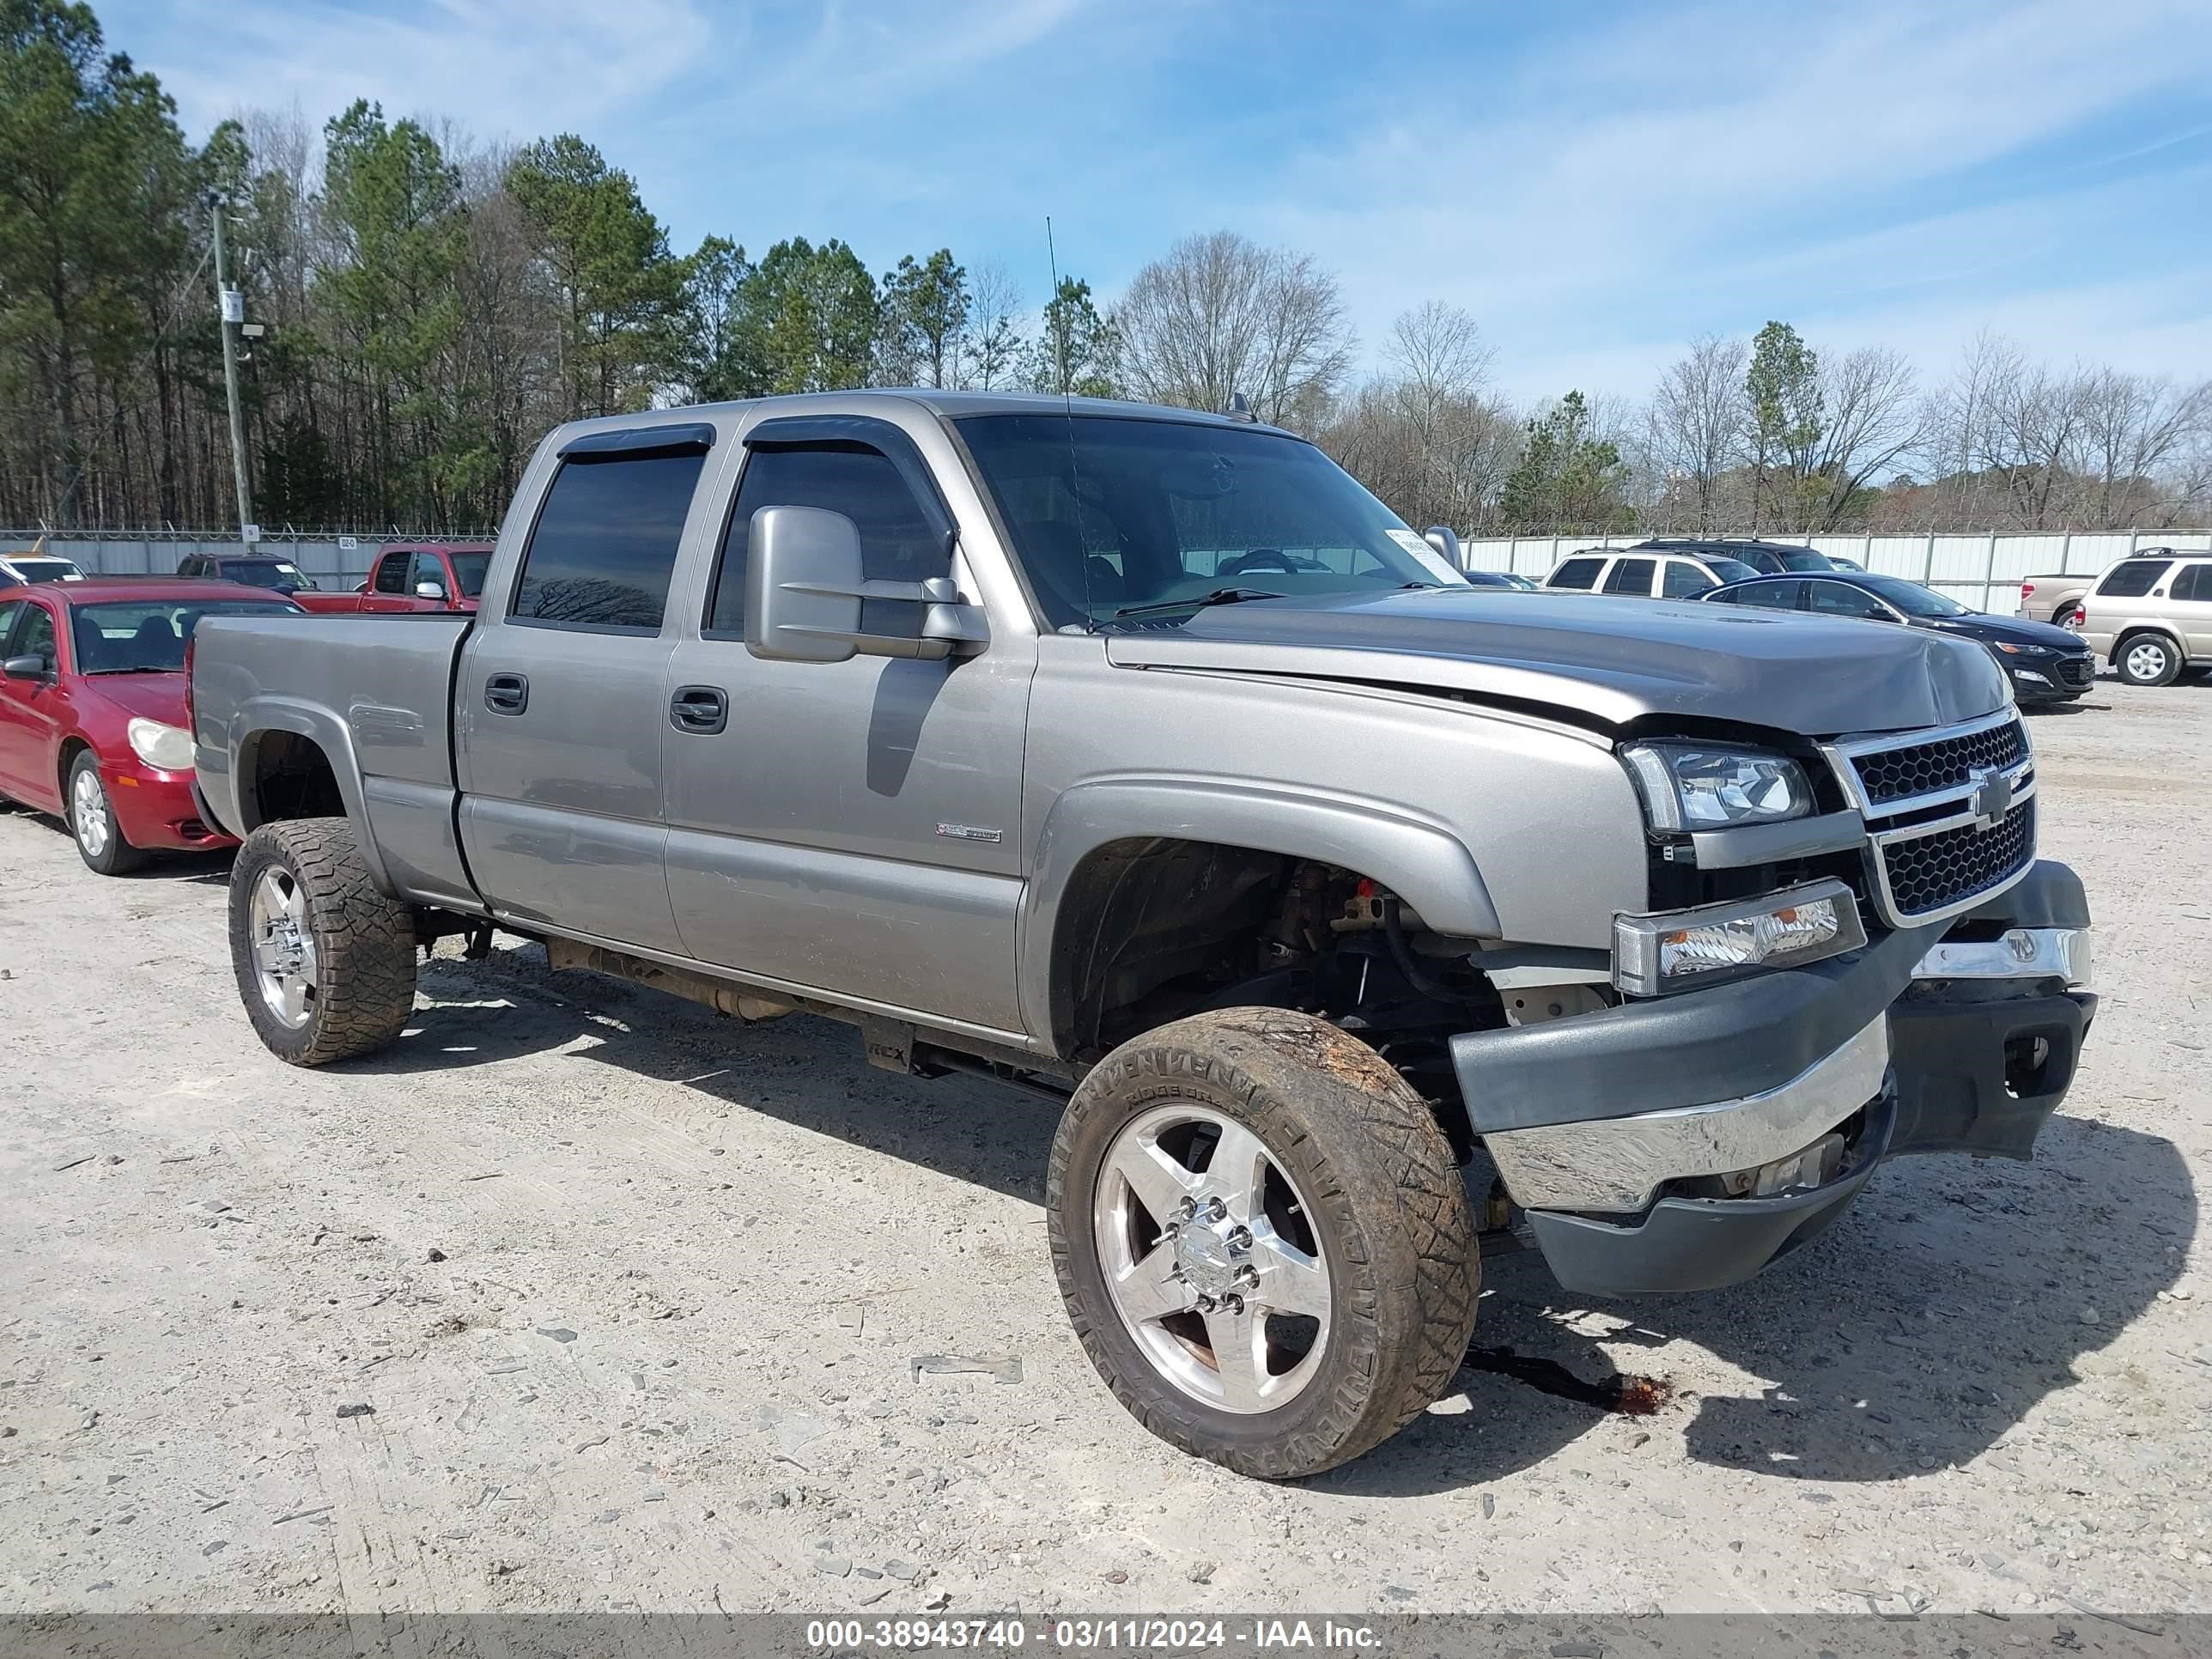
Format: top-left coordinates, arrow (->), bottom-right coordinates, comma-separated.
1460,531 -> 2212,615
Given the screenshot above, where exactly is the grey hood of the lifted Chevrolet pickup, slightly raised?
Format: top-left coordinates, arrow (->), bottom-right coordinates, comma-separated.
1106,588 -> 2011,737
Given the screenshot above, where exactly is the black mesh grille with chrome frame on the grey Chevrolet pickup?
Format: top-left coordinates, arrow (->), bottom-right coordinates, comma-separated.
1827,708 -> 2035,927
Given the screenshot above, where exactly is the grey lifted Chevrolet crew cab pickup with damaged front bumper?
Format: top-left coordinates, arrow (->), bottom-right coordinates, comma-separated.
192,392 -> 2094,1478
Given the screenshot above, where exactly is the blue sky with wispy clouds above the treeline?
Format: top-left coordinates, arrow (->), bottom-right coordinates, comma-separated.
100,0 -> 2212,398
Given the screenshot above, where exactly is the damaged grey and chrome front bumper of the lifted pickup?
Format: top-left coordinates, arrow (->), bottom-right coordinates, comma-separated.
1453,863 -> 2097,1294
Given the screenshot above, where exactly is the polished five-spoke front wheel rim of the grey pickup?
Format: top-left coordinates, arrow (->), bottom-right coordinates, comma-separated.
1091,1102 -> 1329,1413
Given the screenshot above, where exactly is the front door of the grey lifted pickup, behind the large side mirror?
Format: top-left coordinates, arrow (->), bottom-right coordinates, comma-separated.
661,416 -> 1036,1033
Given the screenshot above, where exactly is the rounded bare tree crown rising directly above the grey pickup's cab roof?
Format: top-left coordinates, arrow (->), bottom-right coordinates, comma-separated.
1115,230 -> 1352,429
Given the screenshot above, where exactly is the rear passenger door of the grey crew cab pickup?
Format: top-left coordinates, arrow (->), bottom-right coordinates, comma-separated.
453,425 -> 714,951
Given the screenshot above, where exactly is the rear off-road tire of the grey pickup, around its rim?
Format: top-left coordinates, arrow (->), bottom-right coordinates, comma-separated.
230,818 -> 416,1066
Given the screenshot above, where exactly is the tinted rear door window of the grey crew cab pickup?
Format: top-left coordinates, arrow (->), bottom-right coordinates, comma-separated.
508,453 -> 706,633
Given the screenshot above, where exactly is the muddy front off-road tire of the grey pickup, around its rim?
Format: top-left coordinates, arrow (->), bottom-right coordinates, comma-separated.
1044,1009 -> 1480,1480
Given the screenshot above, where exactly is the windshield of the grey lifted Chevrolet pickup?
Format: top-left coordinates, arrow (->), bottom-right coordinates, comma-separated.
957,414 -> 1462,629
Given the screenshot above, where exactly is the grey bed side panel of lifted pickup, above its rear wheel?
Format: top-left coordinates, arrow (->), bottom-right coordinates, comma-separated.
192,611 -> 480,909
